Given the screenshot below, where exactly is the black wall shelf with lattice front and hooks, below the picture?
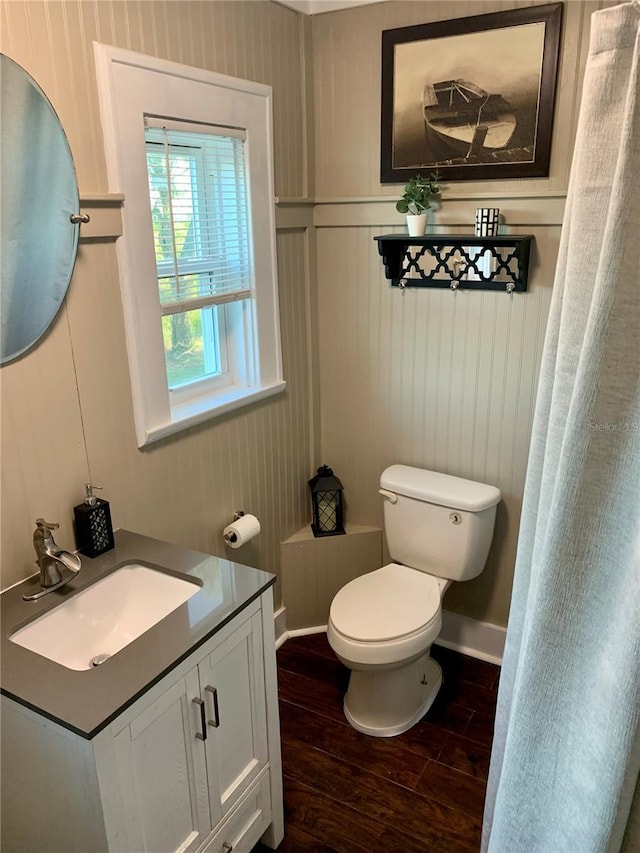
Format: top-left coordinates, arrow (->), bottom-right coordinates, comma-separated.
373,234 -> 533,293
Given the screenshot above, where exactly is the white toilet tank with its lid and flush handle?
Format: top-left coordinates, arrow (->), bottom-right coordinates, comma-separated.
380,465 -> 500,581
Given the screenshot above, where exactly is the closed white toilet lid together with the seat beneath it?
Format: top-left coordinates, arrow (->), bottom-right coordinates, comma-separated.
327,563 -> 442,665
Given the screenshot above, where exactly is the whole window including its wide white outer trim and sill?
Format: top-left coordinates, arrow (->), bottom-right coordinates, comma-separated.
95,45 -> 285,446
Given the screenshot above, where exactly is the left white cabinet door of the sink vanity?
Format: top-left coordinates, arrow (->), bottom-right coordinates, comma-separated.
115,669 -> 213,853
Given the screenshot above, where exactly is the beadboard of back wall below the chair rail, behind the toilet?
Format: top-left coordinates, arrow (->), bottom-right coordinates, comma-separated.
317,226 -> 560,625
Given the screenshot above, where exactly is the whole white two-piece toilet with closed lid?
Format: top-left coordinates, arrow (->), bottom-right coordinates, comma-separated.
327,465 -> 500,737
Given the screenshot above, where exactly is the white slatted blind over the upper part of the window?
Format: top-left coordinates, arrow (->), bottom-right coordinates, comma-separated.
145,117 -> 253,316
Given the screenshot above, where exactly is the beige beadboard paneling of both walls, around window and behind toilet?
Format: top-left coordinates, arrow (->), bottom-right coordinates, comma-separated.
0,0 -> 612,624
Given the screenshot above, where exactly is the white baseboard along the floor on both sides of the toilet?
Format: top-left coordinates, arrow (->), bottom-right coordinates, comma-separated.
274,607 -> 507,665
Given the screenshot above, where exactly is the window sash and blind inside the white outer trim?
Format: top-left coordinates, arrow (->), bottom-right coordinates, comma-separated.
145,118 -> 253,394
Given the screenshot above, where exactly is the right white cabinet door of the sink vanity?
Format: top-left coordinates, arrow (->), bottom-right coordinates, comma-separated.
198,613 -> 267,826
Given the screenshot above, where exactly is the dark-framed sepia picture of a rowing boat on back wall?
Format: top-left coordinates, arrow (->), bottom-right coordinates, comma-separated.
380,3 -> 563,183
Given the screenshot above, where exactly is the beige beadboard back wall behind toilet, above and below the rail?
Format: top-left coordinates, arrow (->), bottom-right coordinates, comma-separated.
313,0 -> 612,625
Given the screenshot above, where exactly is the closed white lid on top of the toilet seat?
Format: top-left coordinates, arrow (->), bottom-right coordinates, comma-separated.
331,563 -> 440,642
